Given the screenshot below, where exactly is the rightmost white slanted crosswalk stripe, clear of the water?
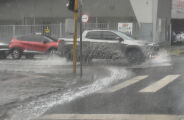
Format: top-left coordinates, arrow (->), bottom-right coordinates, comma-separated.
139,75 -> 180,93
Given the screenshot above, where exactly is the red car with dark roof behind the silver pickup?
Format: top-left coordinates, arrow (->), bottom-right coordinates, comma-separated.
9,35 -> 61,59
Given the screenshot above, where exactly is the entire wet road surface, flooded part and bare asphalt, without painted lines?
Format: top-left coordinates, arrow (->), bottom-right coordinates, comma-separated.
0,53 -> 184,120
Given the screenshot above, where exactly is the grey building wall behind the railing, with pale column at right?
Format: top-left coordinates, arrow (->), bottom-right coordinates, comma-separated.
0,0 -> 171,42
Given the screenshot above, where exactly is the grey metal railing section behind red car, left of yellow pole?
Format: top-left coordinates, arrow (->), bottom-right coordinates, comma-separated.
0,24 -> 64,43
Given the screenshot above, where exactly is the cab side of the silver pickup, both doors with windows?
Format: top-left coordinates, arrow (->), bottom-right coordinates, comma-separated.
86,31 -> 120,59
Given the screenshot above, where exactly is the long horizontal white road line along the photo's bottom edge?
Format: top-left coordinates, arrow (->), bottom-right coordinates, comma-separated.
37,114 -> 184,120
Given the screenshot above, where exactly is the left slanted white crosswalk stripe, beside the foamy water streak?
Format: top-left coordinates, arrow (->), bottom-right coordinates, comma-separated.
98,75 -> 148,93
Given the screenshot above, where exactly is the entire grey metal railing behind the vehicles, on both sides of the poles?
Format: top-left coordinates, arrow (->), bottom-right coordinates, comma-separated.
0,23 -> 118,43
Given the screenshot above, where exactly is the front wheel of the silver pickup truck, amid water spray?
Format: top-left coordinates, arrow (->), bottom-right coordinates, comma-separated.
126,49 -> 145,64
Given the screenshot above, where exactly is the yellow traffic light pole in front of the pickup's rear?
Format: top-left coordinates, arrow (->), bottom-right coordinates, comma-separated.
73,0 -> 78,74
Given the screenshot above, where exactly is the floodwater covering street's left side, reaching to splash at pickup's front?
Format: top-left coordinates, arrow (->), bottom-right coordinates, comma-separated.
0,52 -> 174,120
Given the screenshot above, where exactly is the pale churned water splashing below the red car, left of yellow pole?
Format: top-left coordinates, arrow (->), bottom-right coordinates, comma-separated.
1,56 -> 72,73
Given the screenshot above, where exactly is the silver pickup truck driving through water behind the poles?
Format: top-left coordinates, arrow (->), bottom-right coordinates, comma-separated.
58,30 -> 159,64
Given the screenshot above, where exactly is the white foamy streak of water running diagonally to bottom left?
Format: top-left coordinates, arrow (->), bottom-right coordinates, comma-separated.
6,67 -> 132,120
